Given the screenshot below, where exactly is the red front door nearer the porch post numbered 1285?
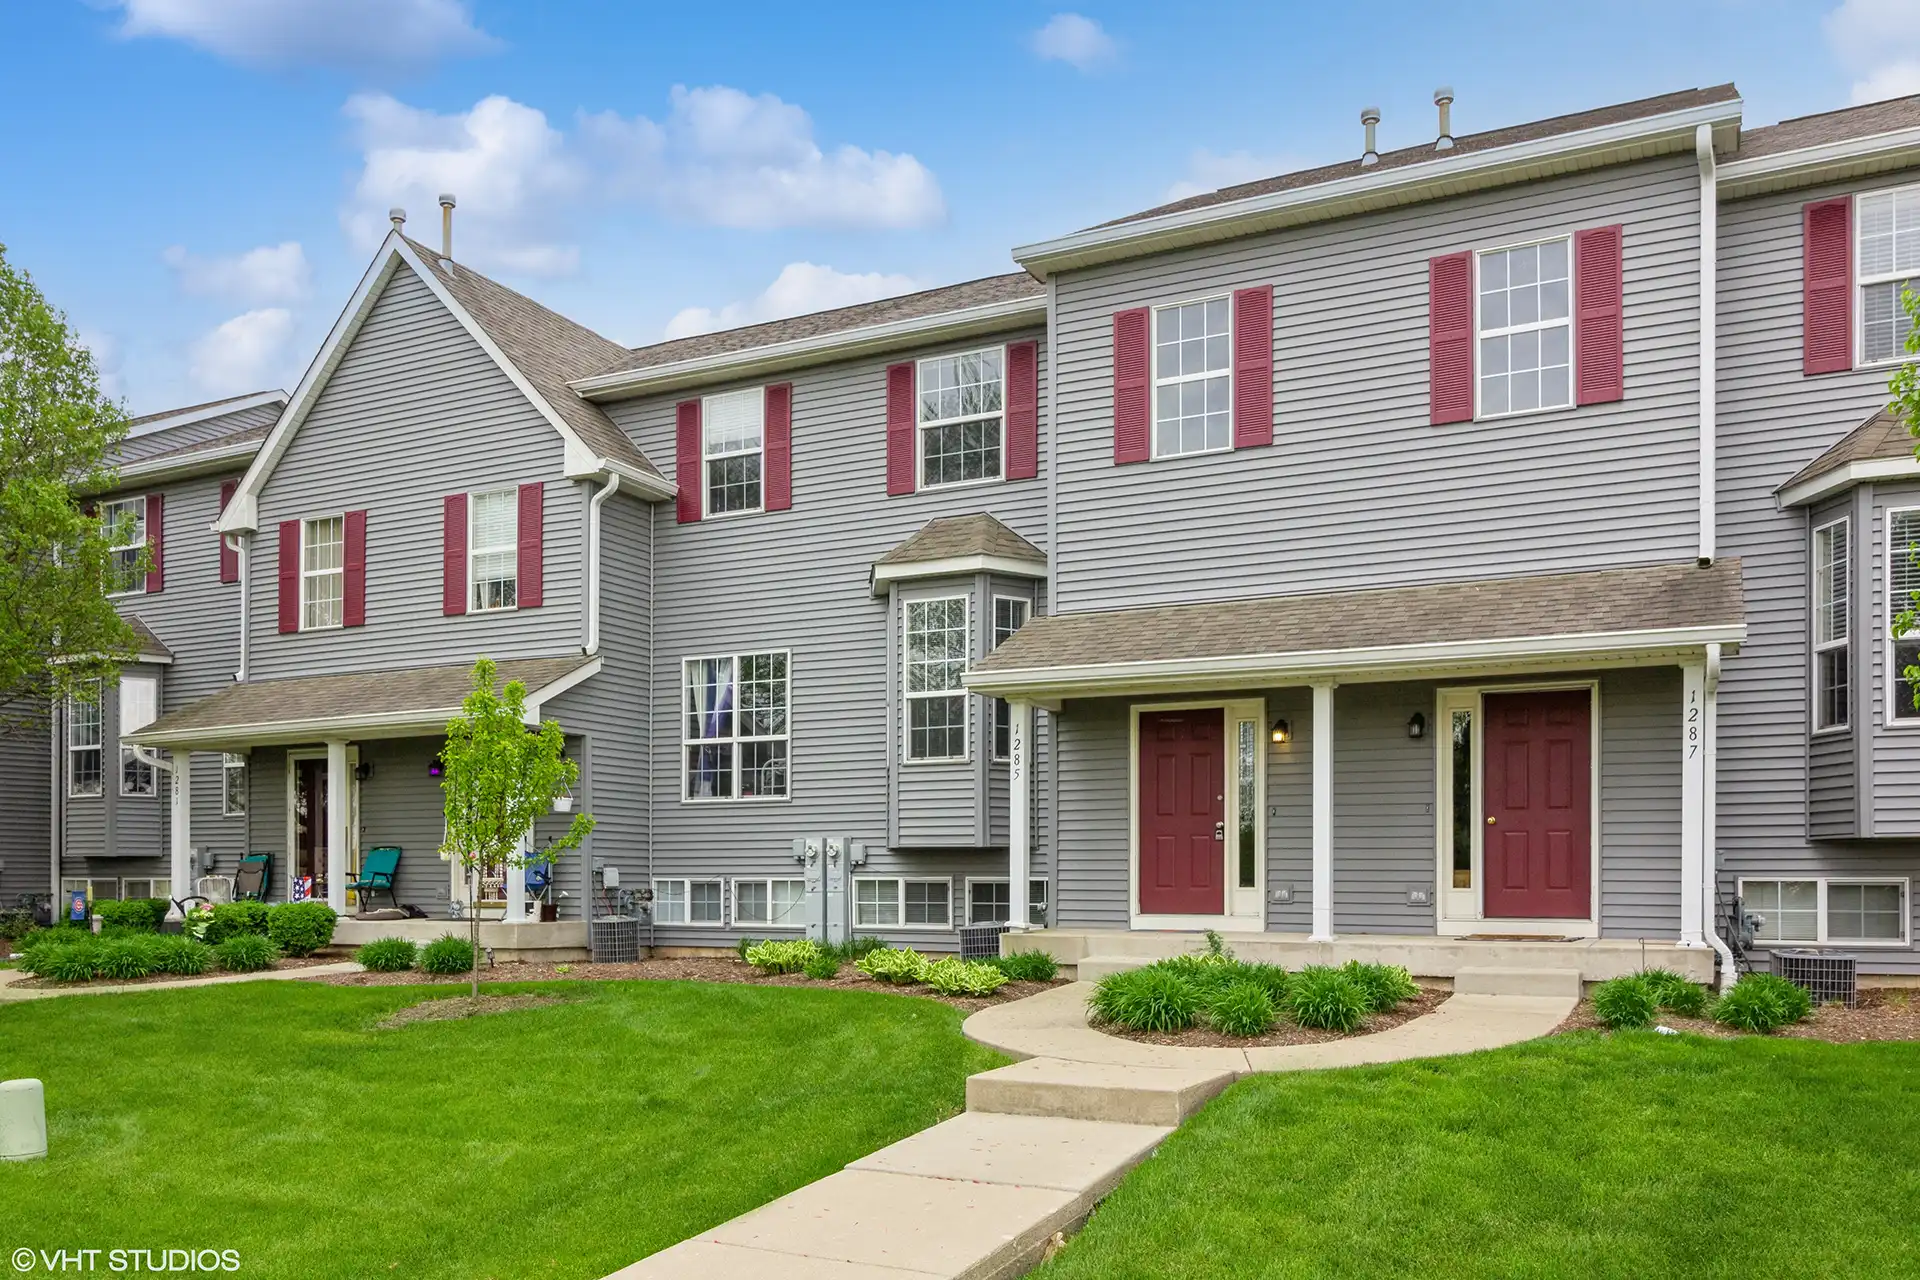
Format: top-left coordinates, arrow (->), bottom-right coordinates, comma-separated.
1140,706 -> 1227,915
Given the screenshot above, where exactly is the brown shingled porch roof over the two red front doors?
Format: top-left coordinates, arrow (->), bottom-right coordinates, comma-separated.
966,558 -> 1745,702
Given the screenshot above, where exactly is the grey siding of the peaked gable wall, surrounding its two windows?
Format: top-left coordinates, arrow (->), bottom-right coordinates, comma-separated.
248,267 -> 582,679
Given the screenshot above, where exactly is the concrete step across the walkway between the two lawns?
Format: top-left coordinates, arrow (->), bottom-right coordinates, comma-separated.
966,1057 -> 1240,1128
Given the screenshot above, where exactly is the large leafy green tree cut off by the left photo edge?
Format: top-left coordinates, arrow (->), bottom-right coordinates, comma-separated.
0,246 -> 146,731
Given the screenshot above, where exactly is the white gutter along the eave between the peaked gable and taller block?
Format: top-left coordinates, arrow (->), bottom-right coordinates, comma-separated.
566,294 -> 1046,399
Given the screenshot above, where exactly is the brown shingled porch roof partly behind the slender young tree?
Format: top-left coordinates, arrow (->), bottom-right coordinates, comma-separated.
127,654 -> 599,750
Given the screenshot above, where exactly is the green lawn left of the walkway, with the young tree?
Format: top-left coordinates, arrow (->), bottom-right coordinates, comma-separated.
0,983 -> 1004,1280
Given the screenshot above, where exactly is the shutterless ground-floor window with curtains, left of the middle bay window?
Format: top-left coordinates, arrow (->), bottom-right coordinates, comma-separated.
682,652 -> 789,800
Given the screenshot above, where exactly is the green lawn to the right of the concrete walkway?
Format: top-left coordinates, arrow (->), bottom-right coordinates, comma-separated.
1037,1032 -> 1920,1280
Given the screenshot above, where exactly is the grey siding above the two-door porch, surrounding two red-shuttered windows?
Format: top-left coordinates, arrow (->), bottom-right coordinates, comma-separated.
1052,157 -> 1699,612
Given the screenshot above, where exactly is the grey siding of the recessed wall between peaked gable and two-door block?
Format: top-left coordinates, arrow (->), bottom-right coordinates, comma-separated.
607,330 -> 1050,946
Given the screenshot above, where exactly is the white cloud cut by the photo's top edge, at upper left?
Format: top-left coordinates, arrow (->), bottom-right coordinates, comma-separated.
113,0 -> 499,71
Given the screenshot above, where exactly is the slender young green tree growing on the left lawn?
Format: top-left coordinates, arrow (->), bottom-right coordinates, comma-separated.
440,658 -> 593,998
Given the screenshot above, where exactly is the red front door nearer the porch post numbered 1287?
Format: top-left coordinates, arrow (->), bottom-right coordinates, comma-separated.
1480,689 -> 1594,919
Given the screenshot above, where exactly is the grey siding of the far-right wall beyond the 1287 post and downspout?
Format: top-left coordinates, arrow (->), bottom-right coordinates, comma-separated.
1716,173 -> 1920,971
